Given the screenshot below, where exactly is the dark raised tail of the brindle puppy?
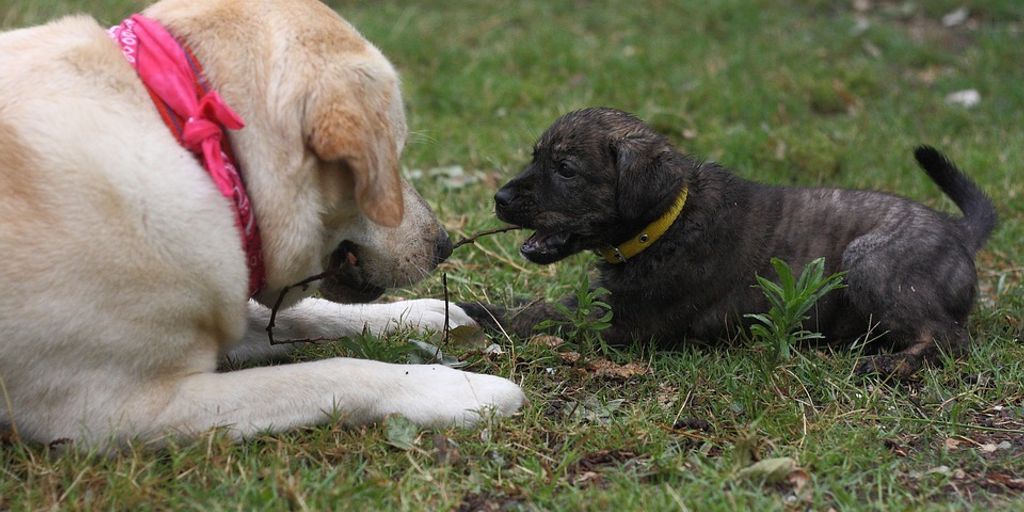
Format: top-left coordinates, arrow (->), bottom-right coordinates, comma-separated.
913,145 -> 996,251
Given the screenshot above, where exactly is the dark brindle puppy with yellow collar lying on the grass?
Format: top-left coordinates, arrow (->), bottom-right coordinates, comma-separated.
469,109 -> 995,376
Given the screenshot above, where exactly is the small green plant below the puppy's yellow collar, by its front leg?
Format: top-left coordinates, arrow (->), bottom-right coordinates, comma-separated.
535,286 -> 614,354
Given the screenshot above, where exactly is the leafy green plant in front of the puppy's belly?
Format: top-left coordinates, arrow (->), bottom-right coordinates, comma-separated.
743,258 -> 846,361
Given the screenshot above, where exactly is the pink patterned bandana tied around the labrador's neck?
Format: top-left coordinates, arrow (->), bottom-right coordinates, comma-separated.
108,14 -> 264,296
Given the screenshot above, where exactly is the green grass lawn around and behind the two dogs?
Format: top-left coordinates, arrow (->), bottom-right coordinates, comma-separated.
0,0 -> 1024,510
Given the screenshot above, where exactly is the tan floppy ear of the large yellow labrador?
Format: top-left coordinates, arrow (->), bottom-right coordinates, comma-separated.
309,99 -> 403,227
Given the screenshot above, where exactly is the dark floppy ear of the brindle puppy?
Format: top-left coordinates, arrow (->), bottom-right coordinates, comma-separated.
610,130 -> 672,220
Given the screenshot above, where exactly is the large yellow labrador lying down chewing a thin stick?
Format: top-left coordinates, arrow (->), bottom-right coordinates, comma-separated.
0,0 -> 523,445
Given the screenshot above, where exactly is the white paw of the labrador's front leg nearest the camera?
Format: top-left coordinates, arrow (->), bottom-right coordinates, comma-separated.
387,365 -> 526,426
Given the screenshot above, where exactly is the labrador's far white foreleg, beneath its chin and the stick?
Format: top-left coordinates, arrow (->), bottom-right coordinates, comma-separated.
224,299 -> 475,362
